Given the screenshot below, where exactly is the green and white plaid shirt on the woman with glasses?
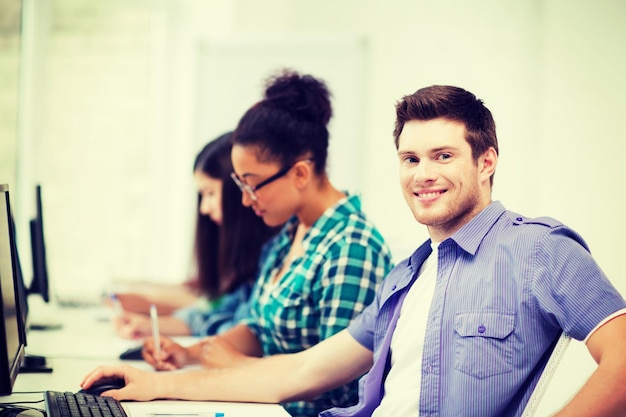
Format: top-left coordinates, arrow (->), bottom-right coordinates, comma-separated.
245,196 -> 393,416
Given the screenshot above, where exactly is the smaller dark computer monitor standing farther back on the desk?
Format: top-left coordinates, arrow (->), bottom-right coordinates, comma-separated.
28,184 -> 50,303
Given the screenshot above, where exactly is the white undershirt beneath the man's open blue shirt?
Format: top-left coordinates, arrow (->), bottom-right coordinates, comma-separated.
372,243 -> 438,417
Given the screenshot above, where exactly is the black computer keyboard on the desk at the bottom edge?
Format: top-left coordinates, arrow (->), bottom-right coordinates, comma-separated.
44,391 -> 128,417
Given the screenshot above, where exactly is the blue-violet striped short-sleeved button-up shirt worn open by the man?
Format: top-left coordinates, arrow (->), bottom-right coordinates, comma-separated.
320,202 -> 626,417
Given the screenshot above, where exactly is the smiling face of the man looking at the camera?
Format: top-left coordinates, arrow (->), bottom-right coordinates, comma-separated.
398,119 -> 497,241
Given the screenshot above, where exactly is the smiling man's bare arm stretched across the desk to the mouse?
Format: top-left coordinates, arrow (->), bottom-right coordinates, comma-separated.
81,330 -> 373,403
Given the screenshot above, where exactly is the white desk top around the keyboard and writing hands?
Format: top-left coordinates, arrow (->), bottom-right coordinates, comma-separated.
0,306 -> 289,417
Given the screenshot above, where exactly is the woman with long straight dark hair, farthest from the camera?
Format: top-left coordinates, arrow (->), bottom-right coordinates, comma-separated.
115,132 -> 278,338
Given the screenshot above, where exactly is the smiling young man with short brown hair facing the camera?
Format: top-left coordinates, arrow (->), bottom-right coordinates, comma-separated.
82,86 -> 626,417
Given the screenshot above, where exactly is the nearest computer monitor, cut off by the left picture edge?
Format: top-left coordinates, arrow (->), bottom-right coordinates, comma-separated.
0,184 -> 26,395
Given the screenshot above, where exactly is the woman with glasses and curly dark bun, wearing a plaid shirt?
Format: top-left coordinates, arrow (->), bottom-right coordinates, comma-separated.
146,71 -> 392,416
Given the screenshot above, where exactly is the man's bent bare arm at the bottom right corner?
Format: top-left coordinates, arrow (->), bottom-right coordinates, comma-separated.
556,314 -> 626,417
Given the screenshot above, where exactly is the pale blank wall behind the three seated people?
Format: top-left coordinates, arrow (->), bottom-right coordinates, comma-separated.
13,0 -> 626,415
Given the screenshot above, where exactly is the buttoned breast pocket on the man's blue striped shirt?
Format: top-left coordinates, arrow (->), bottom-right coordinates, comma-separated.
454,311 -> 515,378
